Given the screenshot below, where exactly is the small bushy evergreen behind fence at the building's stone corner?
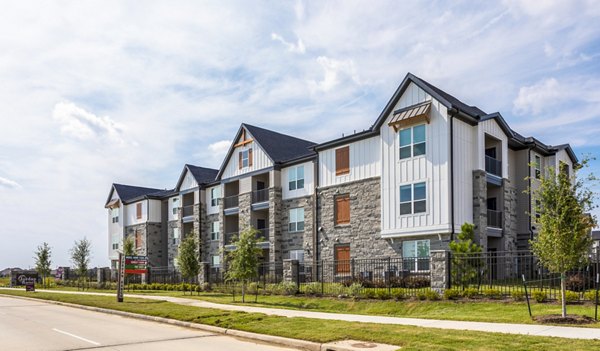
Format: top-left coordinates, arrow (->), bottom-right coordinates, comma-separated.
449,222 -> 481,289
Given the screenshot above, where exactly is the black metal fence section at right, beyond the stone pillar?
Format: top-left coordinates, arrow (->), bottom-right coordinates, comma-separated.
449,251 -> 600,300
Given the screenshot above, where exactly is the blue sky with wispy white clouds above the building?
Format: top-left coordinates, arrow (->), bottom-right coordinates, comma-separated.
0,0 -> 600,268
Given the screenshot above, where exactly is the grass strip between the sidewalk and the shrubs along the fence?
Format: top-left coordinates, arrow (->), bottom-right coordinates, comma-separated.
34,288 -> 600,328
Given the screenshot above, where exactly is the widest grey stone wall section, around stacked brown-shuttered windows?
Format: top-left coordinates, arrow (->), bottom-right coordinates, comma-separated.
317,178 -> 402,260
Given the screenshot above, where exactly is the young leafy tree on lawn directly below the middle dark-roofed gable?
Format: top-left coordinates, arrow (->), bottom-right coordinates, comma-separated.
225,227 -> 261,302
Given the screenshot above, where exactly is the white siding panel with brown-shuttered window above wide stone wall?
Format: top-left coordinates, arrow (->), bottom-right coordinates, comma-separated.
318,136 -> 381,187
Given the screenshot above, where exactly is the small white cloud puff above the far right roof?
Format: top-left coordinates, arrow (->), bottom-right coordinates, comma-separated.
513,78 -> 565,115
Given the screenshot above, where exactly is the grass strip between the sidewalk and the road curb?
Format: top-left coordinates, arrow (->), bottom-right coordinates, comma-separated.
0,290 -> 600,351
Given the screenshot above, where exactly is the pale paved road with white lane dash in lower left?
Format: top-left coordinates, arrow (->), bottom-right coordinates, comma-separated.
0,296 -> 292,351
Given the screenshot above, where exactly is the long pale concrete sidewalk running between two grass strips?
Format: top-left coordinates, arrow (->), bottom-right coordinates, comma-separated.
0,288 -> 600,340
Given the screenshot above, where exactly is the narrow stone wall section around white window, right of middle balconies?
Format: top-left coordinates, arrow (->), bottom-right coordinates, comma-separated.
279,196 -> 314,262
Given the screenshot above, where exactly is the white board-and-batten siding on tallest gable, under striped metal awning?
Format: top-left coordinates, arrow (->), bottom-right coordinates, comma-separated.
380,83 -> 450,237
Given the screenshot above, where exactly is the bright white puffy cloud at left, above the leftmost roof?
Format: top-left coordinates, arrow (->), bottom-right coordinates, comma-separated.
52,102 -> 124,143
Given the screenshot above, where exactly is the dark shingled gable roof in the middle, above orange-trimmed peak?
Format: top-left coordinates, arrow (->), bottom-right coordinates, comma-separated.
216,123 -> 317,179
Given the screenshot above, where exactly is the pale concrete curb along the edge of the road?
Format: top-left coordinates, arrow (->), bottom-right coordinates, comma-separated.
0,292 -> 322,351
